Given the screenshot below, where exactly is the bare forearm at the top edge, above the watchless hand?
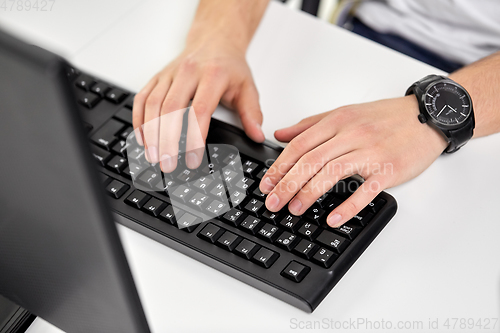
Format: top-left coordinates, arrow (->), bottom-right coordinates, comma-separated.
187,0 -> 269,51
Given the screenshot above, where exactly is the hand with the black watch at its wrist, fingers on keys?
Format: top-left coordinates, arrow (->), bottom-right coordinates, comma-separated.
260,96 -> 447,227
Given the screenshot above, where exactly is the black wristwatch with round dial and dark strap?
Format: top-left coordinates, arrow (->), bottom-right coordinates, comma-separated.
406,75 -> 475,154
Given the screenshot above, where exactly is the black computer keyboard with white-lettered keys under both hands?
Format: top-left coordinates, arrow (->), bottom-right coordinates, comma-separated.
68,65 -> 397,312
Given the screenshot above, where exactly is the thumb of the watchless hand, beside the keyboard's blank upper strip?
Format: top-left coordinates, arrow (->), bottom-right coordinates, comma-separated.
235,82 -> 265,142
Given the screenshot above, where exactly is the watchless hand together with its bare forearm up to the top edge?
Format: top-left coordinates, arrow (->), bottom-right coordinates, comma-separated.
133,1 -> 266,172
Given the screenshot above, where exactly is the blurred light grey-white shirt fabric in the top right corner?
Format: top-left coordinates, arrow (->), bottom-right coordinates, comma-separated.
356,0 -> 500,64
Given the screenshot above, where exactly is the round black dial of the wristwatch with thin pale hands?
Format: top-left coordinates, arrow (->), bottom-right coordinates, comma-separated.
424,82 -> 472,126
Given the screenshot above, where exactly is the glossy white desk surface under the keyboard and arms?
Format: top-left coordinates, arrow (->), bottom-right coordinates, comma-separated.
0,0 -> 500,333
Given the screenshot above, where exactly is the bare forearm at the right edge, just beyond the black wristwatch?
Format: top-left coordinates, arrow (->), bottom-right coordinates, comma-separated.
450,52 -> 500,138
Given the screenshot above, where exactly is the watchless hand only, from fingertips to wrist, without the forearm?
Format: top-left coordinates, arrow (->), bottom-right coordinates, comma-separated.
133,34 -> 264,172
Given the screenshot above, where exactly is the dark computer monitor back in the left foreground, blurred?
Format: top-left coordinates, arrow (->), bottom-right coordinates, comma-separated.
0,31 -> 149,333
